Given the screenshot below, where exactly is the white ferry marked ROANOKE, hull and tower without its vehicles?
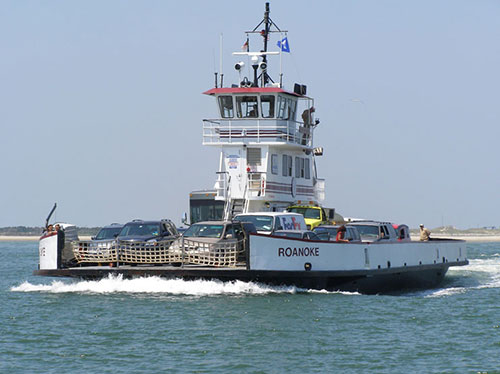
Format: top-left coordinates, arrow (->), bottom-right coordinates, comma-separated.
34,3 -> 468,293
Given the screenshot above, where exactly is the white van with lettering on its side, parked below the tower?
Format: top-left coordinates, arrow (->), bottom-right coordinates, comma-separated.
234,212 -> 307,235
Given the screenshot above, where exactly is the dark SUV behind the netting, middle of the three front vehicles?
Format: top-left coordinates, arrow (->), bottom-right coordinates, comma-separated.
117,219 -> 179,242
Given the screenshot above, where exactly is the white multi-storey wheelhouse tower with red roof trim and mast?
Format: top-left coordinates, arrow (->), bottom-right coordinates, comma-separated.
198,5 -> 325,219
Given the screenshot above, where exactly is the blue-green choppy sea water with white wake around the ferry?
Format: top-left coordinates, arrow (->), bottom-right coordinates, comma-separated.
0,242 -> 500,374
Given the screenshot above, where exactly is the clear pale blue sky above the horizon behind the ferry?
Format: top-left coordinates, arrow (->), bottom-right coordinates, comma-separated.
0,0 -> 500,228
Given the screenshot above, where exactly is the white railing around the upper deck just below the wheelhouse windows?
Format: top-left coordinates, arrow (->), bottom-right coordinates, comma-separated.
203,118 -> 313,147
